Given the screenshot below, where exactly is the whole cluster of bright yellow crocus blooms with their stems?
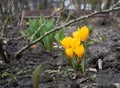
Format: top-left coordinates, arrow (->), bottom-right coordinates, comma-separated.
60,26 -> 89,75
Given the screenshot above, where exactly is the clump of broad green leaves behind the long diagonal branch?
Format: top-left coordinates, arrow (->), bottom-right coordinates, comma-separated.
21,14 -> 55,50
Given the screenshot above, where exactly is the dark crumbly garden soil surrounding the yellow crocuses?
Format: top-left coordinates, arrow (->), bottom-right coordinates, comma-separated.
0,17 -> 120,88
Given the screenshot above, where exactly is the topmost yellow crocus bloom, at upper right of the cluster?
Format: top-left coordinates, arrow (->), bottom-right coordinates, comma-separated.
78,26 -> 89,42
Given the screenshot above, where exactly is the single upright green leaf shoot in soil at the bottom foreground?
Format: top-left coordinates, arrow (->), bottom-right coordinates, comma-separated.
32,65 -> 41,88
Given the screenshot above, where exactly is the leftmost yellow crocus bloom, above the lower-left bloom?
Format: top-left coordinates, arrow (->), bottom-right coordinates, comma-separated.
60,36 -> 73,48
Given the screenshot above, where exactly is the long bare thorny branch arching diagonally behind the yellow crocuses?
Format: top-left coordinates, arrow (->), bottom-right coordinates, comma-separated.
15,7 -> 120,58
